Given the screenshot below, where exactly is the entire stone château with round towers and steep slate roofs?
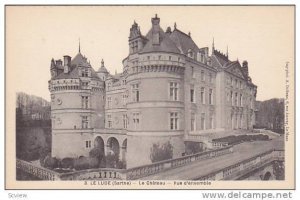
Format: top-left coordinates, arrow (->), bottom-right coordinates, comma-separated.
49,16 -> 257,168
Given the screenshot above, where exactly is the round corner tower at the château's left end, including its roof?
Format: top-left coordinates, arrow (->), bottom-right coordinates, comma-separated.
49,48 -> 104,158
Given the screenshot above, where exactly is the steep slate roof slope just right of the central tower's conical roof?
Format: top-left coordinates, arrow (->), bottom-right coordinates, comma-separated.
170,28 -> 199,54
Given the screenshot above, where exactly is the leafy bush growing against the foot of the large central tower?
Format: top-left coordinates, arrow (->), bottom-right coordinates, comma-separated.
150,141 -> 173,162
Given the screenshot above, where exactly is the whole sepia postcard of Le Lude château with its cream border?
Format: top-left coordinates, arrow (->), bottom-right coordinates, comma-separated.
5,5 -> 295,189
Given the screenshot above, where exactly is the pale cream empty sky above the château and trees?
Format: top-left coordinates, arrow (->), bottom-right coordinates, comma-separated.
6,6 -> 294,100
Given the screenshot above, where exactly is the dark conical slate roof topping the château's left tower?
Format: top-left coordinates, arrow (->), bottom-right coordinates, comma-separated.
55,52 -> 99,79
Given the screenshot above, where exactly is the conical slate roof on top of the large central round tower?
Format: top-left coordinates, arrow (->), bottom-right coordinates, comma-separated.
141,27 -> 180,53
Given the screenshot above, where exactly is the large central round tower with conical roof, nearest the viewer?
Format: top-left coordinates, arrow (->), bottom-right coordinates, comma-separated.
123,16 -> 184,168
